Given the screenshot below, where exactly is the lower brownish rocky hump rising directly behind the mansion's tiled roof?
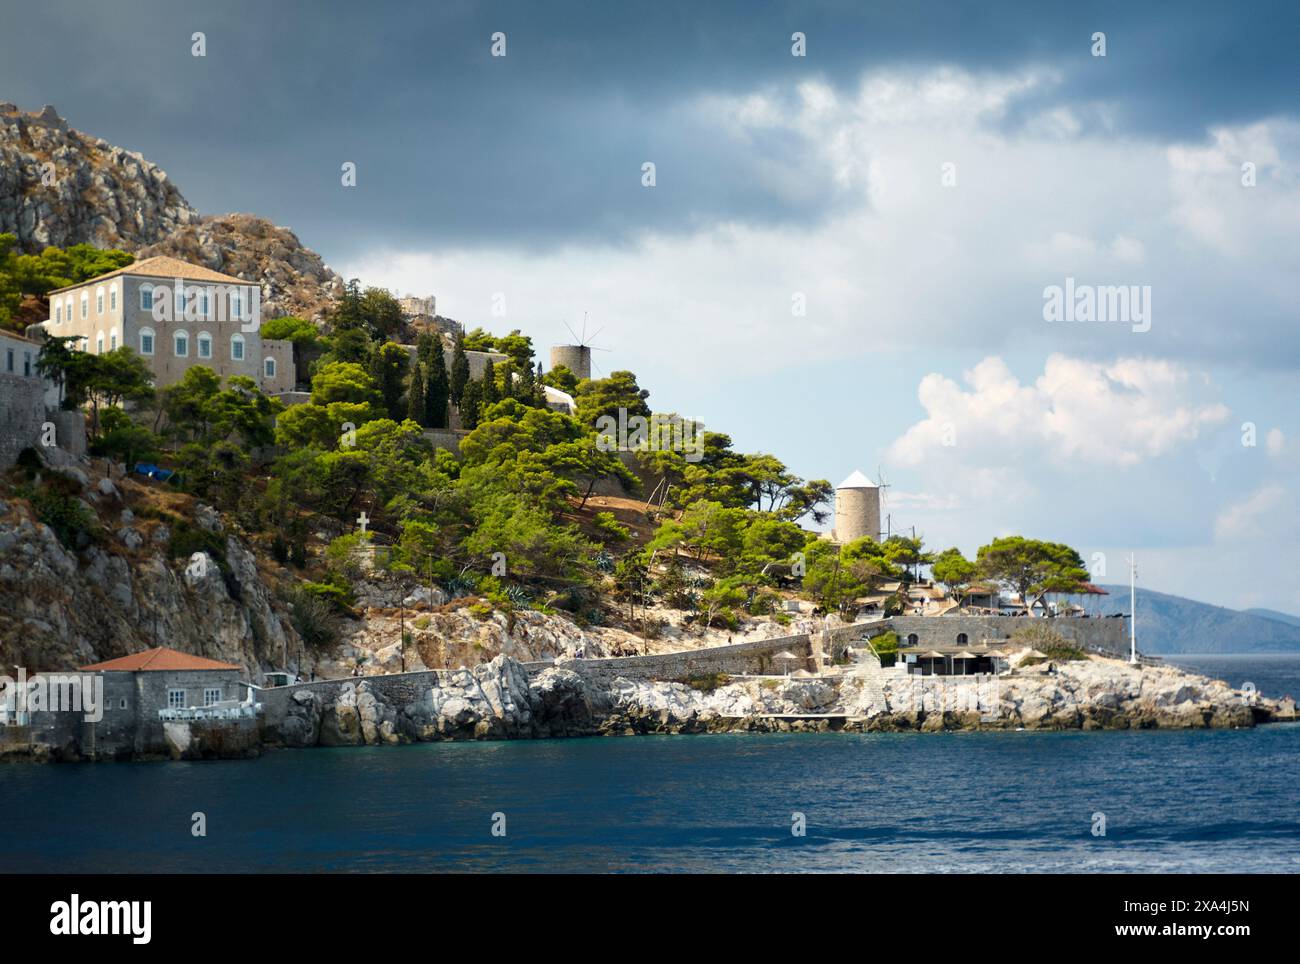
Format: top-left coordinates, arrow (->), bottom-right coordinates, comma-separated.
137,214 -> 343,321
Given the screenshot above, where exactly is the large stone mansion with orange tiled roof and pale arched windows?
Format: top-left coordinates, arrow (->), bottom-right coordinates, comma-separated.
39,257 -> 295,394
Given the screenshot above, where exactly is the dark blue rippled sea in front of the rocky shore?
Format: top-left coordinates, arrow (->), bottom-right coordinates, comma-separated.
0,724 -> 1300,873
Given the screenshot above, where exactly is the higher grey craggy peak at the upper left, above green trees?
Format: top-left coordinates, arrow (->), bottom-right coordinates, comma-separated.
0,104 -> 199,253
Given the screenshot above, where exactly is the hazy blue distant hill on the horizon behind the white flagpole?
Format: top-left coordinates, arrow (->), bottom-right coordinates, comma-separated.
1089,586 -> 1300,653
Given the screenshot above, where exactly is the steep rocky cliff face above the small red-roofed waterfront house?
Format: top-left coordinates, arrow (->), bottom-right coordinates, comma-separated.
0,465 -> 303,678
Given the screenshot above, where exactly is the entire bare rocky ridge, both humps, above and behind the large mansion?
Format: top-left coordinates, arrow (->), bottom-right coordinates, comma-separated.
0,104 -> 343,320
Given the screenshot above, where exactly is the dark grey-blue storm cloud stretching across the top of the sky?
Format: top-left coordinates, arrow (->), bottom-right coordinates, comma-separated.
0,0 -> 1300,257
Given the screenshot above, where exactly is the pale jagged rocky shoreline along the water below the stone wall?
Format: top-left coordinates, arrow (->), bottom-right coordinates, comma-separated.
264,656 -> 1295,747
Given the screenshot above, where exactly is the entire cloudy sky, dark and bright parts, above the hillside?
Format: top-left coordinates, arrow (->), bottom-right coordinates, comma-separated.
0,0 -> 1300,613
